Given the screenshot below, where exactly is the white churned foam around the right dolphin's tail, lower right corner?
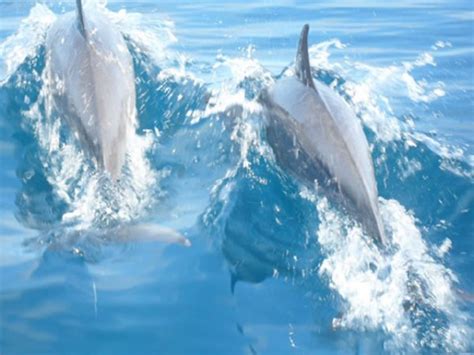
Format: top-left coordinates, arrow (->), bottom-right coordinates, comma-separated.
301,189 -> 472,351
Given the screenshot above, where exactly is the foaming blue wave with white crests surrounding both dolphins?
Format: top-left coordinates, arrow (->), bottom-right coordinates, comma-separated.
0,2 -> 474,352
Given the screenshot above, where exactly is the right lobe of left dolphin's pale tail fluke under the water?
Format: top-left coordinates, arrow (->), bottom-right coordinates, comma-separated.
116,223 -> 191,247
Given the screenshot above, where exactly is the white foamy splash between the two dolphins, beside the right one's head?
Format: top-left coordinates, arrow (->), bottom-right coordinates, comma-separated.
198,46 -> 274,225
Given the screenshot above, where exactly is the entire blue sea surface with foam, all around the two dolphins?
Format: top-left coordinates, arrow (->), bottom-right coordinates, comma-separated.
0,0 -> 474,354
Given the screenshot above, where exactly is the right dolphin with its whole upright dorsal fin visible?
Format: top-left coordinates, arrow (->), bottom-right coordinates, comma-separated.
259,24 -> 386,245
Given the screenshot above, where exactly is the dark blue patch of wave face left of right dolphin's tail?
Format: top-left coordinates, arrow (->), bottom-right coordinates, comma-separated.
203,147 -> 320,288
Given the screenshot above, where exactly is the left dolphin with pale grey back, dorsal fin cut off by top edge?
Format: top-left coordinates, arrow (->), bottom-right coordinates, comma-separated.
46,0 -> 136,179
